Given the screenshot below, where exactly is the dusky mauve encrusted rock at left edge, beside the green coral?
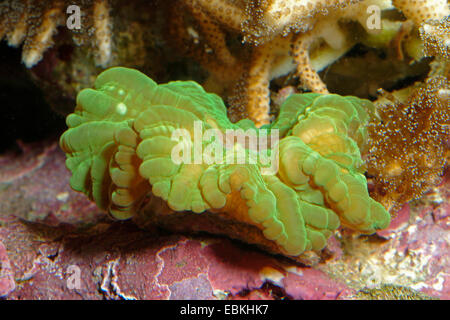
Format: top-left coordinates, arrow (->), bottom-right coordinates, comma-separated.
0,142 -> 103,227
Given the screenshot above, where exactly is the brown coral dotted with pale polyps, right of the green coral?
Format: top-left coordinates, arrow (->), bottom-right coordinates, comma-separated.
367,76 -> 450,211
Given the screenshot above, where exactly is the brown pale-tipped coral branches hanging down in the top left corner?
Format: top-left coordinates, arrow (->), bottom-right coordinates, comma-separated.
0,0 -> 112,68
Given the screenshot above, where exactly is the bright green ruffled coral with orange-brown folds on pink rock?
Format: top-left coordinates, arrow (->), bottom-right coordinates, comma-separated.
60,68 -> 390,256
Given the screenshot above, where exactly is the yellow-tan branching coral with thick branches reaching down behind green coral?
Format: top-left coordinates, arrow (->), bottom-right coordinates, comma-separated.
172,0 -> 418,126
